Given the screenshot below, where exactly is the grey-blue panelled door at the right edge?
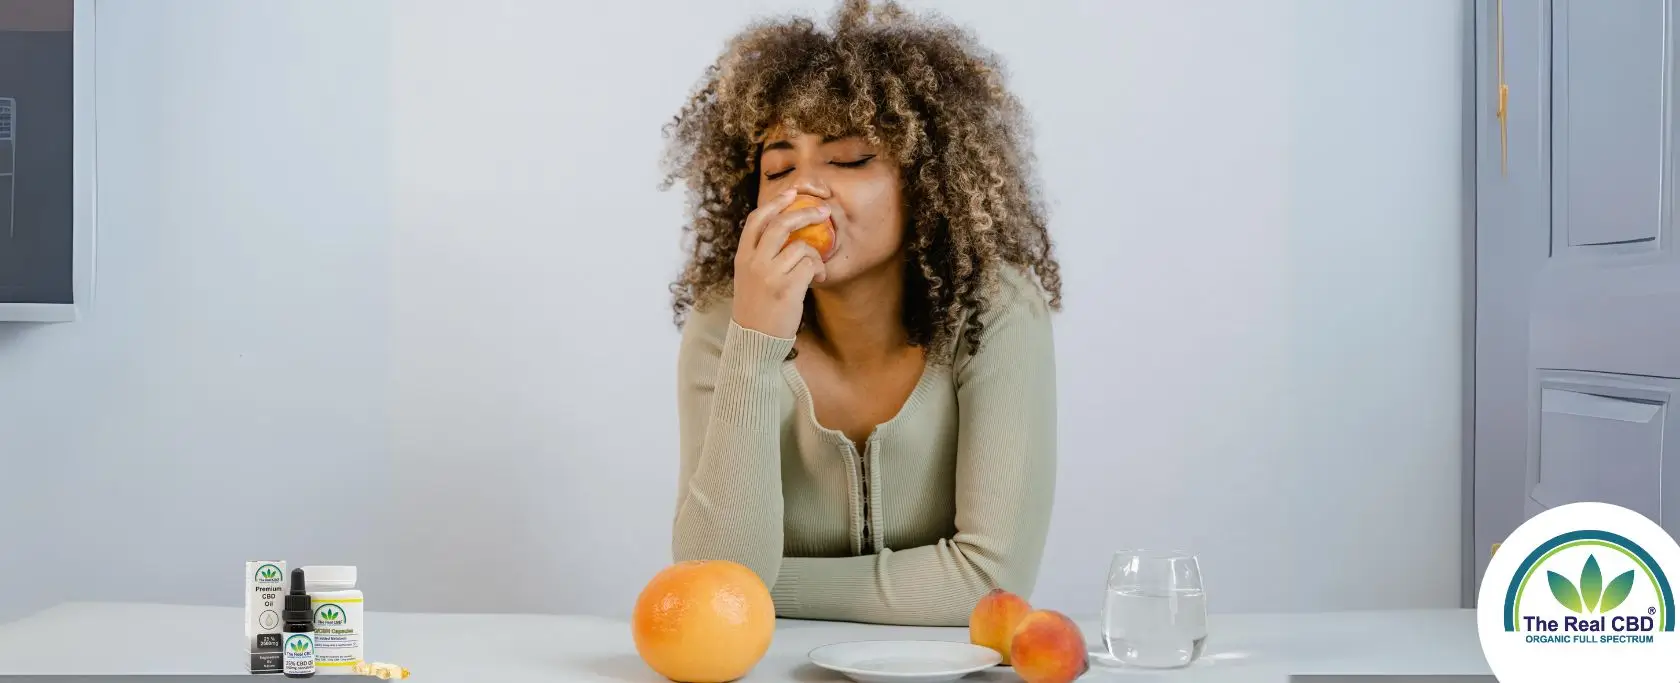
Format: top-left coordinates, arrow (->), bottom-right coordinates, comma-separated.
1465,0 -> 1680,601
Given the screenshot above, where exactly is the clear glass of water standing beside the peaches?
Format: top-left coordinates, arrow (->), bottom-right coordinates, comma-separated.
1102,550 -> 1208,668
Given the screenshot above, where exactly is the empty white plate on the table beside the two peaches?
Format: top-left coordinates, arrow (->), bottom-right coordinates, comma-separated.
810,641 -> 1003,683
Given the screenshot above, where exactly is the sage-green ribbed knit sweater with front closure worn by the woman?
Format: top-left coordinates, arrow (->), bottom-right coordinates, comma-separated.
672,269 -> 1057,626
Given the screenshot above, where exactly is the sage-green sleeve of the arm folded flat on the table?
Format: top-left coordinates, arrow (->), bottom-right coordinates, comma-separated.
771,279 -> 1057,626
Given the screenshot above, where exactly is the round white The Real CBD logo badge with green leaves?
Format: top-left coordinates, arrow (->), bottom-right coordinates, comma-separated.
1477,503 -> 1680,683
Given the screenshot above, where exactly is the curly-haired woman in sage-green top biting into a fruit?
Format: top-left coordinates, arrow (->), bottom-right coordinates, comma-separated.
667,0 -> 1060,626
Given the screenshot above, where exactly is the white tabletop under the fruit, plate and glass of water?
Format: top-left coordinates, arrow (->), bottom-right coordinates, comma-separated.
0,602 -> 1490,683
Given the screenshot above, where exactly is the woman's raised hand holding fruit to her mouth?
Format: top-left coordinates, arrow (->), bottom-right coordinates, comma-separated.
732,191 -> 828,339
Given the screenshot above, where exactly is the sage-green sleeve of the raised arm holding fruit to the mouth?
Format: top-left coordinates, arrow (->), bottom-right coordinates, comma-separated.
672,305 -> 793,586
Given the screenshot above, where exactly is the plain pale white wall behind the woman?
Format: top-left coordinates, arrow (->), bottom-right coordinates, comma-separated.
0,0 -> 1463,624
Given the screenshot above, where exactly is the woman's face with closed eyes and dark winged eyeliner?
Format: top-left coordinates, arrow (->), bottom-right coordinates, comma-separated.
758,133 -> 904,289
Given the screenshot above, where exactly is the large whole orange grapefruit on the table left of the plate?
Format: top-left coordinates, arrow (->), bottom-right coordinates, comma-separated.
630,560 -> 776,683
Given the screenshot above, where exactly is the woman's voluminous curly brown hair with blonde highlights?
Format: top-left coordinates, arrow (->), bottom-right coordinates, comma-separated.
660,0 -> 1062,361
